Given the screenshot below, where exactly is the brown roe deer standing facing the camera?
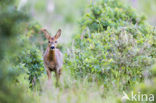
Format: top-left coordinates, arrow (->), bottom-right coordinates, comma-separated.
41,29 -> 63,85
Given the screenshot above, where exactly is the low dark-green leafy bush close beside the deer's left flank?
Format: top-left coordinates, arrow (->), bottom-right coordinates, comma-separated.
18,48 -> 44,88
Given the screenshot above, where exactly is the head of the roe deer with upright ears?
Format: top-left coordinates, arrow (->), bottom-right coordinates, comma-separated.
41,29 -> 61,50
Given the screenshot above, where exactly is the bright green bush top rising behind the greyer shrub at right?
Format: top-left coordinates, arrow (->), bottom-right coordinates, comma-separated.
80,0 -> 145,33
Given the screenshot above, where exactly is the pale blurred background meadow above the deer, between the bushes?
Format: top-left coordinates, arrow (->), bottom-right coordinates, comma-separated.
18,0 -> 89,45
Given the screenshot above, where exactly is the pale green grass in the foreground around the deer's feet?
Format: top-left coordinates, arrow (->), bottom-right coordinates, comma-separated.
20,70 -> 121,103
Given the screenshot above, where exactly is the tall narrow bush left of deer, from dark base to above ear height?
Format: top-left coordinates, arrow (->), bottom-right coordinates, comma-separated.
11,21 -> 44,88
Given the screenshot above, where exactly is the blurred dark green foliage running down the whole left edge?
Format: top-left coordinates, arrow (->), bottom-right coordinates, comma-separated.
0,0 -> 33,103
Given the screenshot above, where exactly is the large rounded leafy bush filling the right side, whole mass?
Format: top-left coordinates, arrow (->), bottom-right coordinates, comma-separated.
65,0 -> 156,90
